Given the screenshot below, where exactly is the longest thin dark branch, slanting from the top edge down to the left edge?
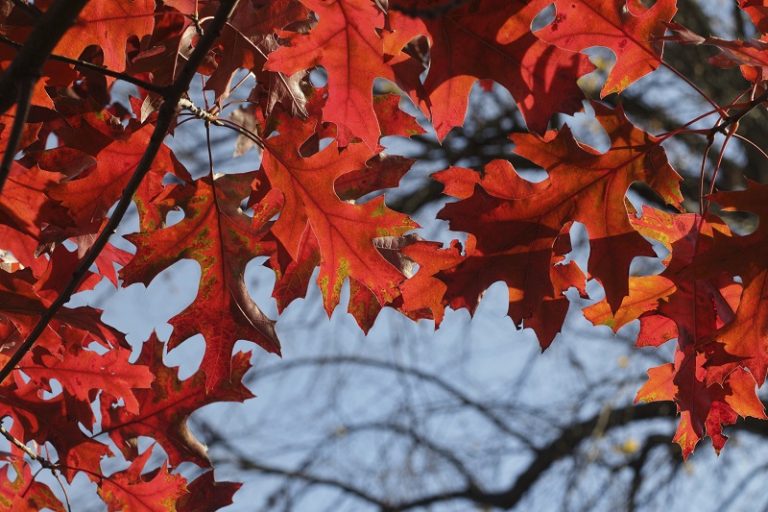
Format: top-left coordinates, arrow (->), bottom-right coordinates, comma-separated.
0,0 -> 239,382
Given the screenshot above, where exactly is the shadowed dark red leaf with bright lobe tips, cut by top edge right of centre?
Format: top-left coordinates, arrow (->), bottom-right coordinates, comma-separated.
391,0 -> 593,139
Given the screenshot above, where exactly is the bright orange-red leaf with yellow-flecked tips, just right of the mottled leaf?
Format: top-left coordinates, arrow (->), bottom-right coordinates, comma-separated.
263,115 -> 417,314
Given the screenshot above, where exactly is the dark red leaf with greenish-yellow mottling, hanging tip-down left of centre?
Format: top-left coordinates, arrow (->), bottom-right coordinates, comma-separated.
120,174 -> 280,391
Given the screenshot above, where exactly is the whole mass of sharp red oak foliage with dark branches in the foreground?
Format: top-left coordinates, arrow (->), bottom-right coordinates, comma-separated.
0,0 -> 768,510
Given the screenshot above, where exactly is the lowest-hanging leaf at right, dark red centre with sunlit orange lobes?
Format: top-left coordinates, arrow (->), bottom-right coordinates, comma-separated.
619,207 -> 765,457
